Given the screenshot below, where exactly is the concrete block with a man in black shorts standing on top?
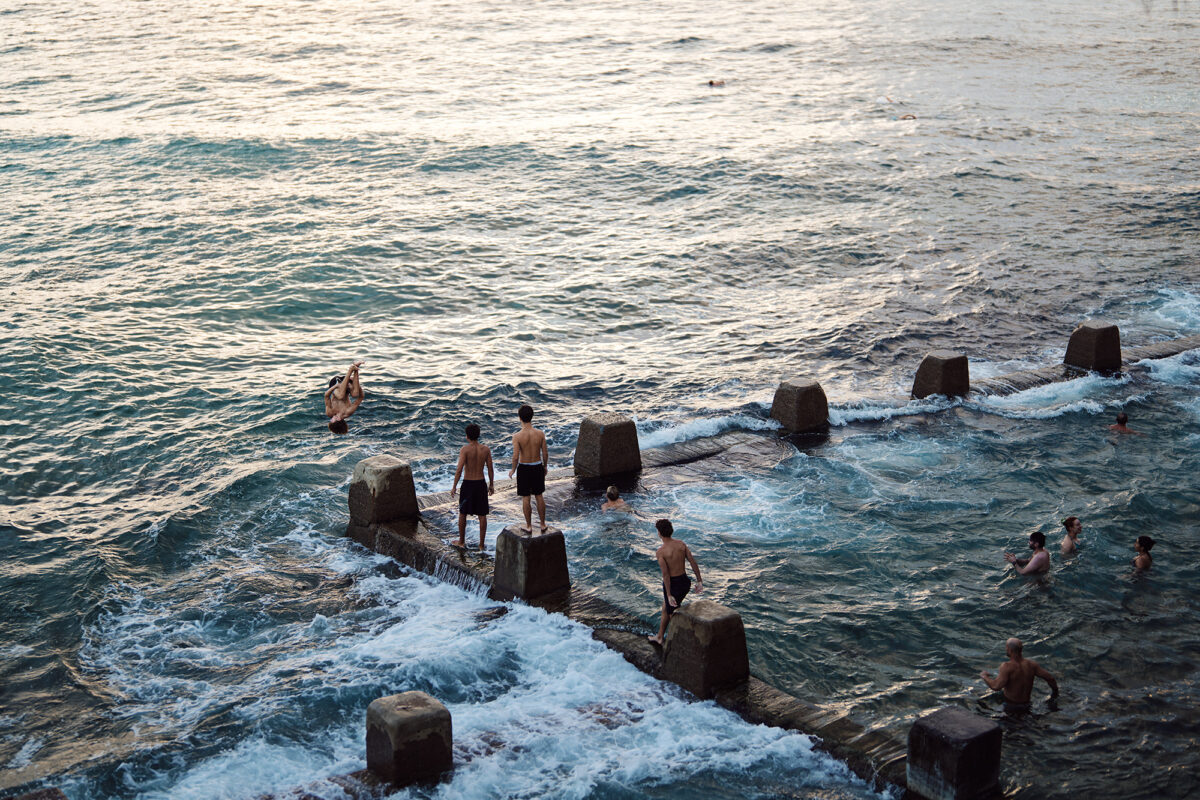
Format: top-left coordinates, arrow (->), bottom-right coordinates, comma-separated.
491,525 -> 571,600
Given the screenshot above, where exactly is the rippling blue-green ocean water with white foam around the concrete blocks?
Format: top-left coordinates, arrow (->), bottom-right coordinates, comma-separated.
0,0 -> 1200,800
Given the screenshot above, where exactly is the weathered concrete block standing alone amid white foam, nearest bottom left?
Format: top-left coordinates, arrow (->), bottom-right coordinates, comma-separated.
367,692 -> 454,786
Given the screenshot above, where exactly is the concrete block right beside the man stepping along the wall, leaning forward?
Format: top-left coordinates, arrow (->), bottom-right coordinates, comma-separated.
662,600 -> 750,699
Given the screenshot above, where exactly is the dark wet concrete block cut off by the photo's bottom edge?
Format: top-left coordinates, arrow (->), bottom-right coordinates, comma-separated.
907,708 -> 1001,800
